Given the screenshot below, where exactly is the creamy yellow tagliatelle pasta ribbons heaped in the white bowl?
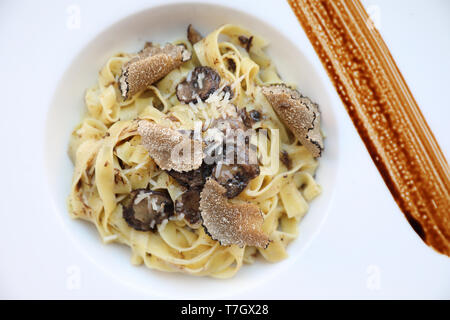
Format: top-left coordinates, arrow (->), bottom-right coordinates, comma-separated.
68,25 -> 321,278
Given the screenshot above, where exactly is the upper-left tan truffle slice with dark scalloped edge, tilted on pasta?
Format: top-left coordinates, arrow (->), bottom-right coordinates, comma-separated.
119,43 -> 191,99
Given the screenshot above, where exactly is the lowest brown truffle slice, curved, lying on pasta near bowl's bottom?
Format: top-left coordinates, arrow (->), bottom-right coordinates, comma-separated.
200,179 -> 269,248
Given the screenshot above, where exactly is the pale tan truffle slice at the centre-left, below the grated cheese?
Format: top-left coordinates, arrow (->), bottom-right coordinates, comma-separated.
138,120 -> 203,172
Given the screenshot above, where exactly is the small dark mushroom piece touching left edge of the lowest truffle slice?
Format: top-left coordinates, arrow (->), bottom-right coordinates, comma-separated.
175,188 -> 202,226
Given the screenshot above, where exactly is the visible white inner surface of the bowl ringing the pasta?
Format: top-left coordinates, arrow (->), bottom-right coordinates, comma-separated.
45,3 -> 338,298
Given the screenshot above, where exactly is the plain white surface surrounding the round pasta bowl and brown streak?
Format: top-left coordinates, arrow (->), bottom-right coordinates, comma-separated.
0,0 -> 450,299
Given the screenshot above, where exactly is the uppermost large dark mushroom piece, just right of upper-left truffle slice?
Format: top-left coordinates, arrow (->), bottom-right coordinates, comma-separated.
177,66 -> 220,103
